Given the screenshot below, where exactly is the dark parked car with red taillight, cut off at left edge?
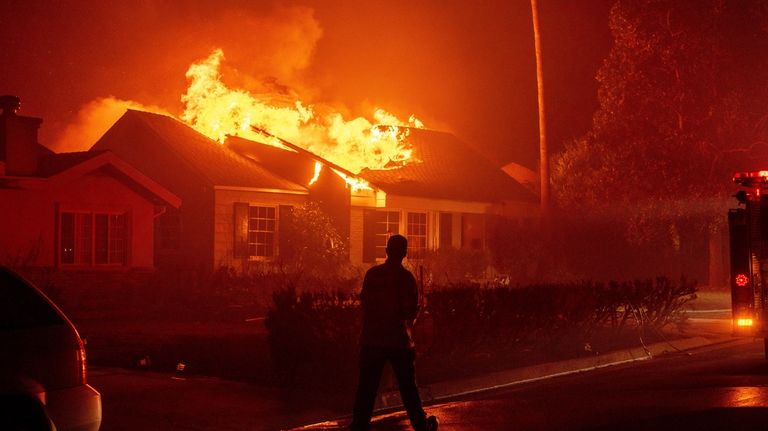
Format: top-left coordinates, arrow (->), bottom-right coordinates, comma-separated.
0,266 -> 101,431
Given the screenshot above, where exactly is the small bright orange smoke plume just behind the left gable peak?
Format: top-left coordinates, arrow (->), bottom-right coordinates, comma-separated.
51,96 -> 170,152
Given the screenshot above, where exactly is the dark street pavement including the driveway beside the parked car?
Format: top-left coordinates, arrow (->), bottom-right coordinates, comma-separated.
84,319 -> 768,431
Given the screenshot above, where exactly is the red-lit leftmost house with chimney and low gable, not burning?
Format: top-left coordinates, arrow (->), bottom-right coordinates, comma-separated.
0,96 -> 180,270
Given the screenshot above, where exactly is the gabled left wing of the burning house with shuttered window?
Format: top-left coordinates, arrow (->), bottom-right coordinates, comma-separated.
91,110 -> 309,271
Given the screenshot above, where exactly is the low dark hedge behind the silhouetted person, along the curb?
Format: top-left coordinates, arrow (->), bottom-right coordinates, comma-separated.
266,277 -> 696,387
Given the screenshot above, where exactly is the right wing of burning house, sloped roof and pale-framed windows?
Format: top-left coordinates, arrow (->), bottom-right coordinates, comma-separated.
351,129 -> 539,262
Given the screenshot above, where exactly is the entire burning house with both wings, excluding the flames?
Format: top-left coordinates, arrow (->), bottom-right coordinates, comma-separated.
87,106 -> 538,269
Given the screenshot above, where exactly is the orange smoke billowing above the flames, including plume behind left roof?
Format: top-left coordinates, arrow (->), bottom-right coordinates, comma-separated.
51,2 -> 323,152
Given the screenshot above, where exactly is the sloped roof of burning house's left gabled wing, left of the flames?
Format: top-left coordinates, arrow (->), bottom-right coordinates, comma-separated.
91,109 -> 307,193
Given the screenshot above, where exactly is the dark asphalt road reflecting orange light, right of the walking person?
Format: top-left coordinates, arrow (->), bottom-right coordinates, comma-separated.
310,339 -> 768,431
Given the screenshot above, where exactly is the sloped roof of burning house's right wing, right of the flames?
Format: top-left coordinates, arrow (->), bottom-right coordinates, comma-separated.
359,129 -> 537,203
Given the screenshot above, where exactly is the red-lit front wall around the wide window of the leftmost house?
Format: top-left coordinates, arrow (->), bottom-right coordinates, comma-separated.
0,172 -> 154,268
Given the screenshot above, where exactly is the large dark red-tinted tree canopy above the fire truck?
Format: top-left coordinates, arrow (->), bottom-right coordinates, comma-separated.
553,0 -> 768,208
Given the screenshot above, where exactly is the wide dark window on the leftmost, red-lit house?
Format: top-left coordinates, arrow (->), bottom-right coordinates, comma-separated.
59,212 -> 128,265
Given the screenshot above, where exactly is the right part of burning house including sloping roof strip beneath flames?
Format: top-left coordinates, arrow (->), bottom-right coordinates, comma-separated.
227,125 -> 538,264
